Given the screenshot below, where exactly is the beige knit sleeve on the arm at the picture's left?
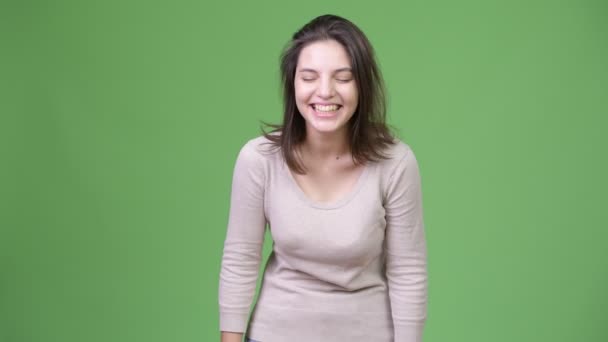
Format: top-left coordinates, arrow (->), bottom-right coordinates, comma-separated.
219,142 -> 266,332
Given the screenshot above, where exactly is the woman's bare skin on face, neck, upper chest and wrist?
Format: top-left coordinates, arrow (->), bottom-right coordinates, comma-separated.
221,40 -> 362,342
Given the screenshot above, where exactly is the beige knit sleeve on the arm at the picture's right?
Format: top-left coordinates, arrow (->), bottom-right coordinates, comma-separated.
385,148 -> 428,342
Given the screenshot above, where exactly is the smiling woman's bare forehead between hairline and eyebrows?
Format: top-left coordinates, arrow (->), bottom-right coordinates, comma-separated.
298,40 -> 351,71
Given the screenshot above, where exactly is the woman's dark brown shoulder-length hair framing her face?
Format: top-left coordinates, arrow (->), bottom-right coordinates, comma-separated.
262,14 -> 395,173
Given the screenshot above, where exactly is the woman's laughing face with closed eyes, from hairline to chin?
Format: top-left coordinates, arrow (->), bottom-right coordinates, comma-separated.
294,40 -> 359,138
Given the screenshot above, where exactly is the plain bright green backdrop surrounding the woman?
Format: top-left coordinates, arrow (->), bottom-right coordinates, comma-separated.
0,0 -> 608,342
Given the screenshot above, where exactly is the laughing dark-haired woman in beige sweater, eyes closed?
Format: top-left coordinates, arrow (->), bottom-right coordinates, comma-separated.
219,15 -> 428,342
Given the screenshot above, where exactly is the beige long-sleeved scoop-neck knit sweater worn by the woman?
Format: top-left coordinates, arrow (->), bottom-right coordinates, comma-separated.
219,136 -> 428,342
